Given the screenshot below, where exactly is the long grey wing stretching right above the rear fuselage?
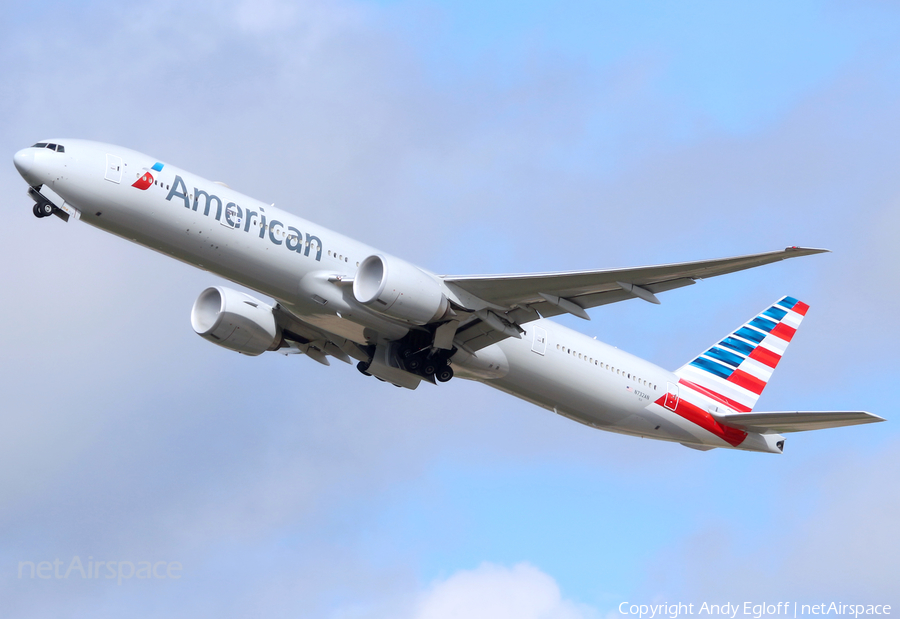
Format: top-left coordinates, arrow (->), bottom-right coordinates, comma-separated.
442,247 -> 828,351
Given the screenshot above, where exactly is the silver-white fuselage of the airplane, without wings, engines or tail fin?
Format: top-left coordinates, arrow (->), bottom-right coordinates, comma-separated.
16,140 -> 771,451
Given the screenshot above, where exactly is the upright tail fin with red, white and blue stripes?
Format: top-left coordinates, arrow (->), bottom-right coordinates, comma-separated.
675,297 -> 809,413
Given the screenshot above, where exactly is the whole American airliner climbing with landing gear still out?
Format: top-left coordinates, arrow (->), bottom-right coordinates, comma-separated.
14,139 -> 884,453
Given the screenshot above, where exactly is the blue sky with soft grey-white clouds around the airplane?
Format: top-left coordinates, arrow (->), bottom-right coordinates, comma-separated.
0,0 -> 900,619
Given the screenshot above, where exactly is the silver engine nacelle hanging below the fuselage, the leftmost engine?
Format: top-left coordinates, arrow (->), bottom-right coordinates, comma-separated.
191,286 -> 281,356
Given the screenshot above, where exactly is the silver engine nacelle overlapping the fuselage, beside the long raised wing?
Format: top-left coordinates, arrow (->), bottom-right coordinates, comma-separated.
353,254 -> 450,325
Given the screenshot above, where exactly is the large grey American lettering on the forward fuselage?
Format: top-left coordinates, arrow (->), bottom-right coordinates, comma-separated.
164,174 -> 322,261
